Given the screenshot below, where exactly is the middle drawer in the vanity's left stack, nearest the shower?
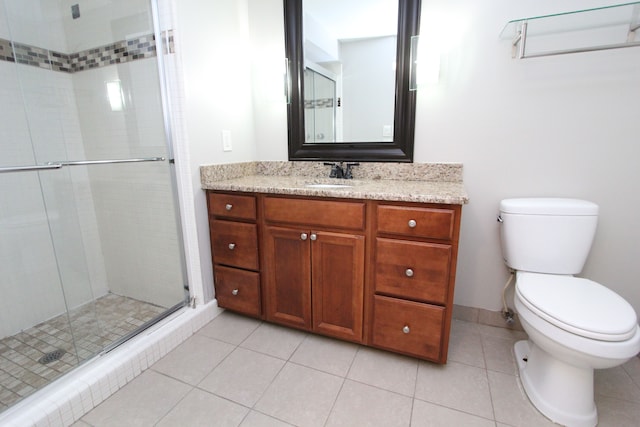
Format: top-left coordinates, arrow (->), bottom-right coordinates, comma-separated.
209,219 -> 259,270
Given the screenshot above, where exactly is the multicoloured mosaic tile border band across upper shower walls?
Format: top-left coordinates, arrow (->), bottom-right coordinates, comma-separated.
0,30 -> 175,73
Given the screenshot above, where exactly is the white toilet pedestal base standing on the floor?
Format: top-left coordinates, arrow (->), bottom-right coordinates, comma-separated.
514,340 -> 598,427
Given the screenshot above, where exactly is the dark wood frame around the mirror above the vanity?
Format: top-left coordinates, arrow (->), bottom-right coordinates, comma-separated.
283,0 -> 421,162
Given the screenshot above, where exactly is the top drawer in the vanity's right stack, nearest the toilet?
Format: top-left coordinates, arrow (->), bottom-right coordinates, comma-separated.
377,205 -> 455,240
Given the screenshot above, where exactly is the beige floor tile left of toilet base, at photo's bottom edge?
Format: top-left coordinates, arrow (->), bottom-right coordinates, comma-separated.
487,371 -> 555,427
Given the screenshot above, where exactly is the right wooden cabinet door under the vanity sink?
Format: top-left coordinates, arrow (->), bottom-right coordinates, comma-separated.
311,232 -> 364,342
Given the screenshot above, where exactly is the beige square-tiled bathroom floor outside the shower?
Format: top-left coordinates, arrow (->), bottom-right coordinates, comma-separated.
75,312 -> 640,427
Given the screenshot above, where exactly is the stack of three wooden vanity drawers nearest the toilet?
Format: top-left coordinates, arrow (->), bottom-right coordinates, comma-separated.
370,202 -> 461,363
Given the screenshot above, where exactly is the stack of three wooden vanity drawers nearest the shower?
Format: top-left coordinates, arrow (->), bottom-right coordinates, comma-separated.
207,192 -> 262,317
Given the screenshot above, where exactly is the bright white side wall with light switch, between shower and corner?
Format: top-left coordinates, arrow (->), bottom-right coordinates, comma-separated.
172,0 -> 262,300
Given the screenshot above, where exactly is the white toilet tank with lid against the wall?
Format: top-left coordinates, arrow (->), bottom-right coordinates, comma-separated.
498,198 -> 598,274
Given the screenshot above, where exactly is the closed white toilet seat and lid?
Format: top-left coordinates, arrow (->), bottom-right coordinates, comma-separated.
516,272 -> 638,341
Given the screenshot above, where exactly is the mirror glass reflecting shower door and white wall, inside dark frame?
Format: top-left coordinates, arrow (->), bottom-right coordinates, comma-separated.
303,0 -> 398,143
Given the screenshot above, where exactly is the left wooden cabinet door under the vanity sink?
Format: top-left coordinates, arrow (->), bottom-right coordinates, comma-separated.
263,227 -> 311,329
